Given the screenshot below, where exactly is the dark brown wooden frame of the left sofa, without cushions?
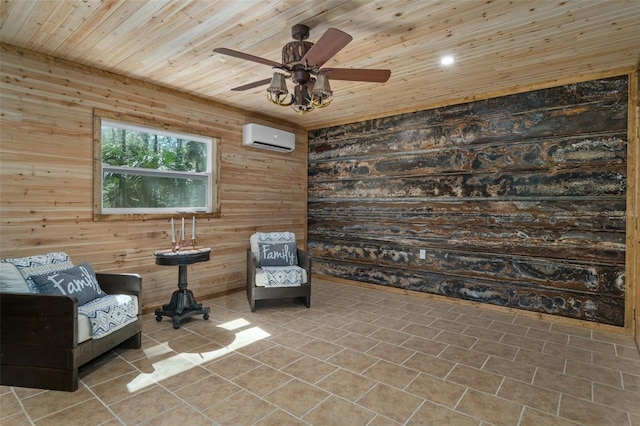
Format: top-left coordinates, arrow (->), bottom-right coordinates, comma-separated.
0,273 -> 142,391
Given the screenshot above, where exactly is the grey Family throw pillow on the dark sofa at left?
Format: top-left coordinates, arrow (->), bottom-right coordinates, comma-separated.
31,262 -> 106,305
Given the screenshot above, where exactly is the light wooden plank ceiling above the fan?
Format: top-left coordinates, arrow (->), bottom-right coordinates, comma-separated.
0,0 -> 640,129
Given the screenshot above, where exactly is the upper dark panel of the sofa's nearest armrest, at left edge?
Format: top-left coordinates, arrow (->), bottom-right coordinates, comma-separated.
0,293 -> 78,347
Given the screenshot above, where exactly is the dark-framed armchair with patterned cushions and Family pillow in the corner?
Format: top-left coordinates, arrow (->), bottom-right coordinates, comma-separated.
247,232 -> 311,312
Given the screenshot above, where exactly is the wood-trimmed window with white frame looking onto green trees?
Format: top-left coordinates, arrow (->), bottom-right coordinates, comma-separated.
95,114 -> 217,215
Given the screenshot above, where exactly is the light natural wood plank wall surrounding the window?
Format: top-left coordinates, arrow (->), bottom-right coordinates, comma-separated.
0,45 -> 307,312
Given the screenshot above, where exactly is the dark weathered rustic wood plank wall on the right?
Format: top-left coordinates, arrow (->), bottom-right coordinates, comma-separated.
308,75 -> 628,326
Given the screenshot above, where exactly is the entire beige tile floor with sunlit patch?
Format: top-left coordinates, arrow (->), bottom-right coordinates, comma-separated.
0,280 -> 640,426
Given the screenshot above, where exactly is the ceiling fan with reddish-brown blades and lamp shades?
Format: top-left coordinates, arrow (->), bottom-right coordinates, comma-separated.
213,24 -> 391,113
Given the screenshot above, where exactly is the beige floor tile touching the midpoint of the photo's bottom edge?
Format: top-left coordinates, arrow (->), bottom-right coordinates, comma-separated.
304,396 -> 375,426
